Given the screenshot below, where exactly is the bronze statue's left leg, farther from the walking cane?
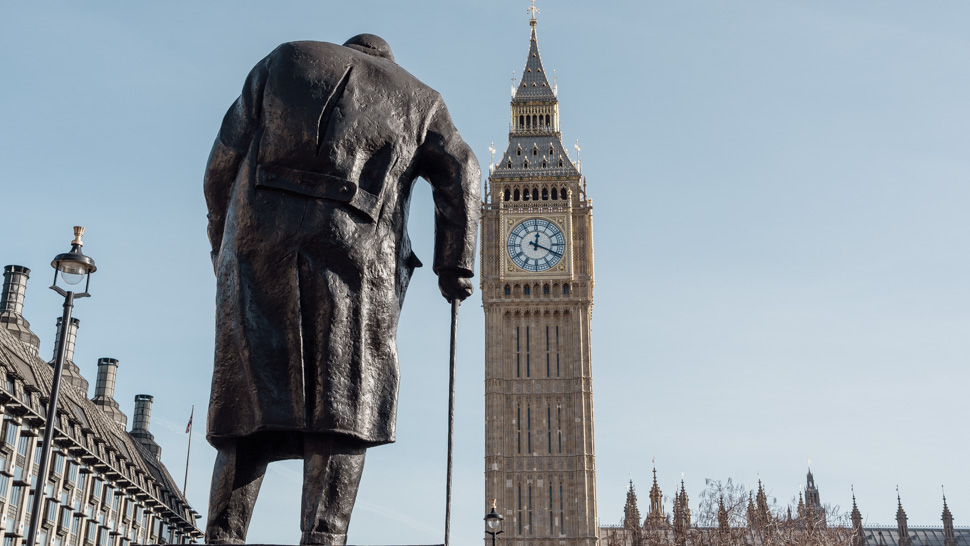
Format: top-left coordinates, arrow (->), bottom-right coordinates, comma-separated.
205,439 -> 268,544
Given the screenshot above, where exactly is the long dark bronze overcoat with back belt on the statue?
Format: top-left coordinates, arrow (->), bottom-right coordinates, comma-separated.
205,42 -> 480,445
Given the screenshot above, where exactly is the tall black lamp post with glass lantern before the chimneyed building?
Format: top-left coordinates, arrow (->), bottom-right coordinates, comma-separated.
24,226 -> 98,546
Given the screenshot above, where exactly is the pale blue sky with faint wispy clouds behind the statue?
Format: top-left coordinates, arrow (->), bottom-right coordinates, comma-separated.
0,0 -> 970,544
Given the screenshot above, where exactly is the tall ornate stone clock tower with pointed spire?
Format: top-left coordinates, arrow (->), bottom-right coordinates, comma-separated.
481,0 -> 599,546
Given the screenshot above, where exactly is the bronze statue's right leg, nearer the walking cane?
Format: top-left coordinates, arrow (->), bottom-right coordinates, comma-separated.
300,434 -> 366,545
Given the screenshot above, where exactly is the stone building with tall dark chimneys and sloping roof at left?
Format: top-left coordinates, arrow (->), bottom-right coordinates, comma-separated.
0,266 -> 202,546
